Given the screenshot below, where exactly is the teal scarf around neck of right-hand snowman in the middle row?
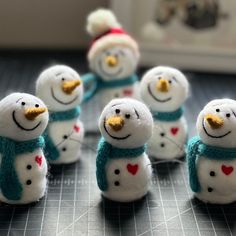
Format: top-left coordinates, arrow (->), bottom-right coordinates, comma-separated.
152,107 -> 183,122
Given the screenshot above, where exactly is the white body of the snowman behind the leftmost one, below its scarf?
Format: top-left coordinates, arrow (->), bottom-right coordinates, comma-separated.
48,119 -> 84,164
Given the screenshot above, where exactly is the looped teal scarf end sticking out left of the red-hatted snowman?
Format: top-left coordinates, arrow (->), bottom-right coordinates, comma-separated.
81,73 -> 98,103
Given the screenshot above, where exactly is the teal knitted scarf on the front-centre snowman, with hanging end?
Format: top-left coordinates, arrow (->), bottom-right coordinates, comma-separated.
96,138 -> 146,191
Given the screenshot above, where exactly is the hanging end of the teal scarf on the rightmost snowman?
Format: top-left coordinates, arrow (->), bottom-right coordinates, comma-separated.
187,136 -> 201,193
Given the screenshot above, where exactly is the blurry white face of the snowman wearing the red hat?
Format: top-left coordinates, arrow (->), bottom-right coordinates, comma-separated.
90,45 -> 139,81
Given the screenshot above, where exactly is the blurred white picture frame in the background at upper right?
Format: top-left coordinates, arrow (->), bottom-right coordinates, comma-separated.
111,0 -> 236,73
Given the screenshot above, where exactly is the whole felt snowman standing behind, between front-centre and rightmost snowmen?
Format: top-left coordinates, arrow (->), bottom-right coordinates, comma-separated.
140,66 -> 189,160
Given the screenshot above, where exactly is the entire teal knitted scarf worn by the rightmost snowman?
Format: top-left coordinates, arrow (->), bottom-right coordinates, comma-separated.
187,136 -> 236,192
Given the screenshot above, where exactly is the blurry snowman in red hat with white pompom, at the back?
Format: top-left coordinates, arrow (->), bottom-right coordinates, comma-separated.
82,9 -> 139,109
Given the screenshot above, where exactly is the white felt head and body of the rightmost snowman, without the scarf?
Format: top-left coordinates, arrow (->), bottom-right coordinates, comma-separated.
190,99 -> 236,204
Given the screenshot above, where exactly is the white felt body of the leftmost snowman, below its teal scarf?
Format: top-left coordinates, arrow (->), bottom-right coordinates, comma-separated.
0,149 -> 48,204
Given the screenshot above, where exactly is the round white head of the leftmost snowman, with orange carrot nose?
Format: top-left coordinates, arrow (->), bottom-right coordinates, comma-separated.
0,93 -> 49,141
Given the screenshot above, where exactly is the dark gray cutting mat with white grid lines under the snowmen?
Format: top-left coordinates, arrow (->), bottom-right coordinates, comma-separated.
0,53 -> 236,236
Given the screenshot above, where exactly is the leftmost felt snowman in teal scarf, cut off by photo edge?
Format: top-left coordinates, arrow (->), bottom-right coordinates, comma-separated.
0,93 -> 48,204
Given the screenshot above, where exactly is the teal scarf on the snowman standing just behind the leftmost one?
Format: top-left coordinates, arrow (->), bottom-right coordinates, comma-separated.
44,106 -> 80,161
